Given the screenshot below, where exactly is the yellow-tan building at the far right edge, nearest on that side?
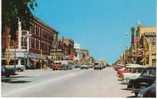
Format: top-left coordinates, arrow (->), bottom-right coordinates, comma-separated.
139,27 -> 156,66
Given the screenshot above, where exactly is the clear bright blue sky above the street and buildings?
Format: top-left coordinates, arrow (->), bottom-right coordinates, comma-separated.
34,0 -> 156,63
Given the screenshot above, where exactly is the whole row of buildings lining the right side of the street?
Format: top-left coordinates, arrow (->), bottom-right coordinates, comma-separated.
116,24 -> 156,66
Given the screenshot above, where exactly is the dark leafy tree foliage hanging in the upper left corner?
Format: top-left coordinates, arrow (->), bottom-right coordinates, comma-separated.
2,0 -> 37,39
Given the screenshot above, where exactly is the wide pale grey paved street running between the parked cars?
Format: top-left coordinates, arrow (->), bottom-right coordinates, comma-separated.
2,68 -> 133,97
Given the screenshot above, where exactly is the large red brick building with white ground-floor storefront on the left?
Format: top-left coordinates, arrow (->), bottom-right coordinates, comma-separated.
2,17 -> 58,68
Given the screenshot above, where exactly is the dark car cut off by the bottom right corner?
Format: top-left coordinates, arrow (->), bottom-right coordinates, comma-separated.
138,82 -> 156,98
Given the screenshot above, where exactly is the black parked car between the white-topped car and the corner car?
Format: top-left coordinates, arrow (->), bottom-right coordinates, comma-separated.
127,67 -> 156,96
